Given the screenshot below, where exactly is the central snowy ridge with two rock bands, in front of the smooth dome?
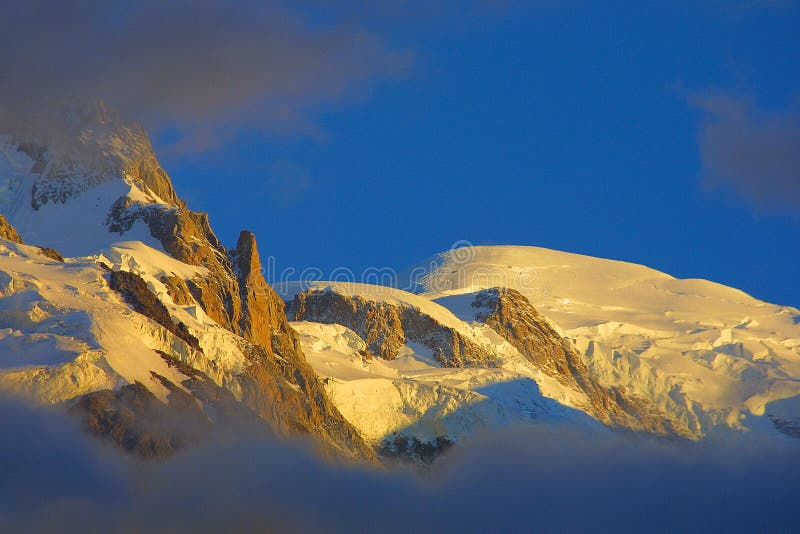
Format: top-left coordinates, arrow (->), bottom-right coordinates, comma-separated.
288,282 -> 691,446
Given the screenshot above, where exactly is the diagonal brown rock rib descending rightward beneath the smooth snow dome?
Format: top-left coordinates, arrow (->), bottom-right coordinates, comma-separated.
472,288 -> 690,436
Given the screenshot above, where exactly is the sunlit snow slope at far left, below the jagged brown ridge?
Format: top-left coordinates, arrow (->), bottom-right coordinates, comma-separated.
0,240 -> 250,403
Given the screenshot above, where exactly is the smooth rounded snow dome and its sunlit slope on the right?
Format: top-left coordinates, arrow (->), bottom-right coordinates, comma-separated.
407,246 -> 800,435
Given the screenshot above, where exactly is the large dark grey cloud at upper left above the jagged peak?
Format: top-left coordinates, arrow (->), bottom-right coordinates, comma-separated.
0,0 -> 408,148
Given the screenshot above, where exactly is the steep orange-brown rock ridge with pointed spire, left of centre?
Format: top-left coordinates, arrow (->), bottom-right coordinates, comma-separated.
108,204 -> 375,461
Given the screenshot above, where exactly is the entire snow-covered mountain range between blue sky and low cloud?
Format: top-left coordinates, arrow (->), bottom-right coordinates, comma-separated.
0,105 -> 800,462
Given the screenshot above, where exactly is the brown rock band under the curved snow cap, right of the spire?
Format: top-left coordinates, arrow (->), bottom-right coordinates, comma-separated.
288,289 -> 495,367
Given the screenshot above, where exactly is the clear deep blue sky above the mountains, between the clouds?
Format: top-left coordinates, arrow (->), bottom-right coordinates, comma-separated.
156,1 -> 800,306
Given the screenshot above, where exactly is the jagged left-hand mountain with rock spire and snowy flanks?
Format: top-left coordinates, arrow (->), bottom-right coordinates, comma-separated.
0,106 -> 373,460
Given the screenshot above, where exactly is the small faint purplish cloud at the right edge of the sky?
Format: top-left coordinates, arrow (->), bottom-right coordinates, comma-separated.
690,94 -> 800,211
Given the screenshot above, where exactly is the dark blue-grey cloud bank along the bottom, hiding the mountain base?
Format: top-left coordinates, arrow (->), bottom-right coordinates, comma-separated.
0,400 -> 800,532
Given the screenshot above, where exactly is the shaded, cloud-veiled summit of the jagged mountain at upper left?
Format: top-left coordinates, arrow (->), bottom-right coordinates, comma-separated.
0,101 -> 185,256
